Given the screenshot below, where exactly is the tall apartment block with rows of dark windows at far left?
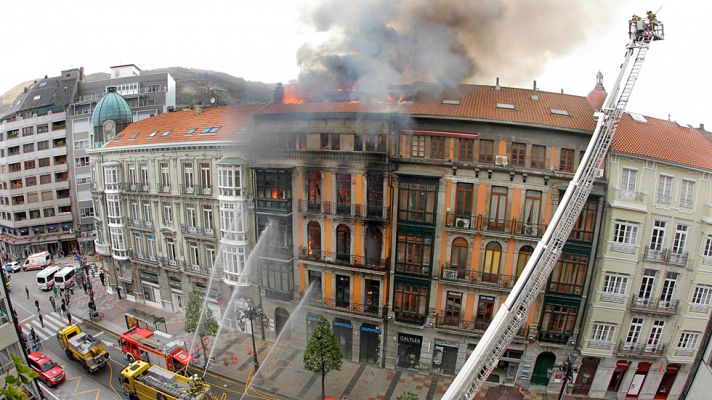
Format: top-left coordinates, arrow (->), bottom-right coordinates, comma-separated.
0,69 -> 83,259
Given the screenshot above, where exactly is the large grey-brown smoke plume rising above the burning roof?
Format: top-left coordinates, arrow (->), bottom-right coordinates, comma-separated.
297,0 -> 605,101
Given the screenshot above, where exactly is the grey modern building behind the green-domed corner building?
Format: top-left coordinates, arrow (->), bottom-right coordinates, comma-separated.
66,64 -> 176,254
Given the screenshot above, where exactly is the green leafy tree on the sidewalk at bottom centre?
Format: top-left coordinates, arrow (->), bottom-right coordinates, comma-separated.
304,317 -> 343,400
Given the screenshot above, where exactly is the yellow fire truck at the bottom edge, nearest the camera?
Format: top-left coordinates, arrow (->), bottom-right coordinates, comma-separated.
119,361 -> 215,400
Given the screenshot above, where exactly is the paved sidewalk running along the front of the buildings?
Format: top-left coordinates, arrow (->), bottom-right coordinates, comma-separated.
72,276 -> 588,400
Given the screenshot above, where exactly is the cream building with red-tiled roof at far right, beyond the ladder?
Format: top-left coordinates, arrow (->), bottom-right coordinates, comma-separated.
574,113 -> 712,399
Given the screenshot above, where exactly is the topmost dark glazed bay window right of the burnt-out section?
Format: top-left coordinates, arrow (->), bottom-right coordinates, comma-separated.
398,179 -> 438,224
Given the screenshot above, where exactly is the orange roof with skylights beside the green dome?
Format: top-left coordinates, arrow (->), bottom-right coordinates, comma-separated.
104,104 -> 265,148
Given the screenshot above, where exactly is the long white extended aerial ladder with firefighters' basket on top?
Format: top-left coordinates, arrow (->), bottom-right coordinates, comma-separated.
442,16 -> 664,400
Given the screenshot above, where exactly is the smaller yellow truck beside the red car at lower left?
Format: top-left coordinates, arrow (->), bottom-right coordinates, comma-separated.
57,324 -> 109,373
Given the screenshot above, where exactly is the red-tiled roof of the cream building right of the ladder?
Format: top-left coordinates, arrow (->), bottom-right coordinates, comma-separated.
611,113 -> 712,170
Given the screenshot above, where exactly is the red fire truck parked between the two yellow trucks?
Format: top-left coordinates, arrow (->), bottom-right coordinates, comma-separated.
119,327 -> 193,372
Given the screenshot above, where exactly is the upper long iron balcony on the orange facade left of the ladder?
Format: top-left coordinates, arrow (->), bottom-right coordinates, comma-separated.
445,213 -> 546,238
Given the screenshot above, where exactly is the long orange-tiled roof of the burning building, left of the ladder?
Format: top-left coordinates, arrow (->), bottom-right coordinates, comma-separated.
259,84 -> 596,132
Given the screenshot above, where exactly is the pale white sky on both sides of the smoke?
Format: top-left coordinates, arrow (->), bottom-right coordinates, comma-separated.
0,0 -> 712,129
